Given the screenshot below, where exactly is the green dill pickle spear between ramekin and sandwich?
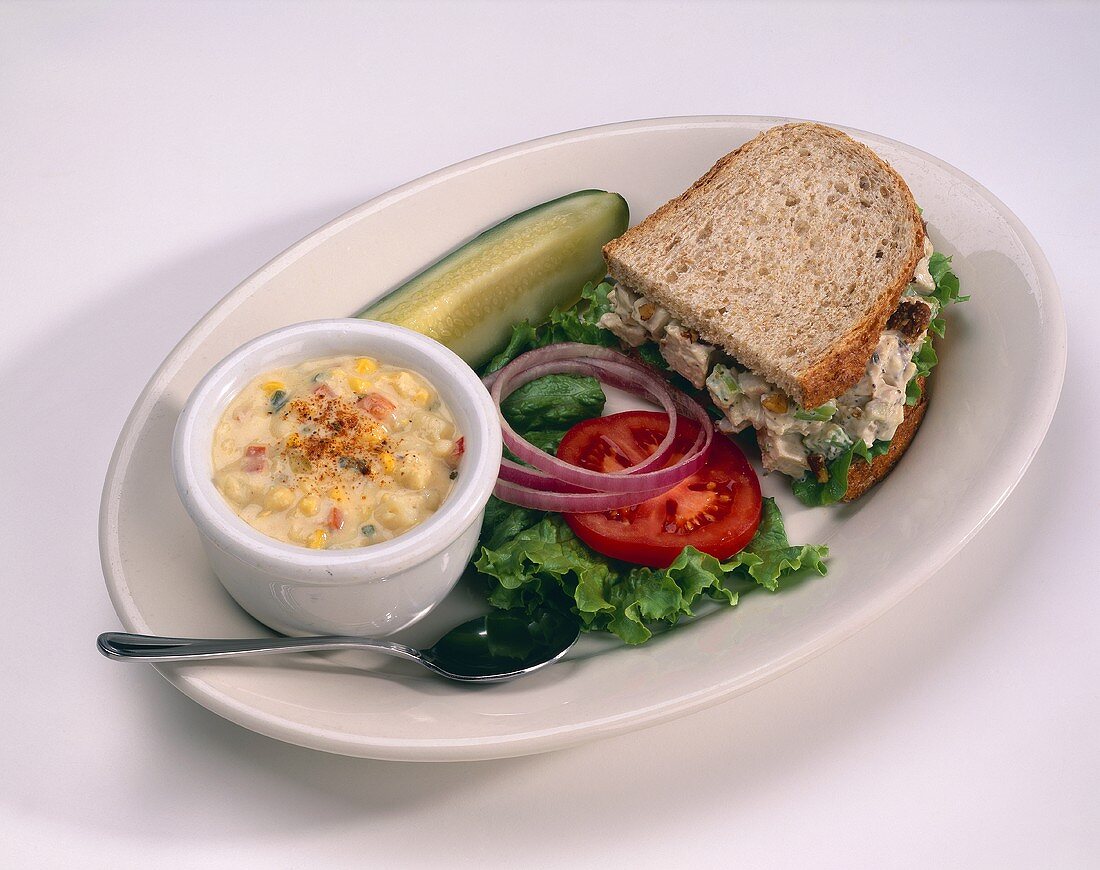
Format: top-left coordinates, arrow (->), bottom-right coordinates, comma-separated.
356,190 -> 629,368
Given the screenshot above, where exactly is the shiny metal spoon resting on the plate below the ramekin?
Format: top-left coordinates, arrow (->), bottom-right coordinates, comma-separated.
96,612 -> 581,683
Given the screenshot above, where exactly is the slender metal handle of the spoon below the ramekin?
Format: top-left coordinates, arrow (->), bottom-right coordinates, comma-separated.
96,631 -> 422,663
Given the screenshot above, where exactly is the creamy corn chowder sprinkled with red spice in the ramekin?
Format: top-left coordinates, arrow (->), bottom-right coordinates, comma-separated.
213,356 -> 463,549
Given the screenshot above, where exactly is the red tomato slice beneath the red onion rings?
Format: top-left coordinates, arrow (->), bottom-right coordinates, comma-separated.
558,411 -> 760,568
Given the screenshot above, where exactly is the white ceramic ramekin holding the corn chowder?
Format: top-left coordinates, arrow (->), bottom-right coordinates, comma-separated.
172,320 -> 501,637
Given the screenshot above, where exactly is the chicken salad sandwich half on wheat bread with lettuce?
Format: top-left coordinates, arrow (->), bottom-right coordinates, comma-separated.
601,123 -> 959,504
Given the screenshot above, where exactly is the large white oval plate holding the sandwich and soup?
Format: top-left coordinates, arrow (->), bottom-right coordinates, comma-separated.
100,117 -> 1066,760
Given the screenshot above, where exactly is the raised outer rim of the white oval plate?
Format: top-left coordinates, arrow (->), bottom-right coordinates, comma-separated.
99,114 -> 1068,761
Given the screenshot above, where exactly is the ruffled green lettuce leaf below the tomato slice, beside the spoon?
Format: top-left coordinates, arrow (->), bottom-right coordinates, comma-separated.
474,498 -> 828,643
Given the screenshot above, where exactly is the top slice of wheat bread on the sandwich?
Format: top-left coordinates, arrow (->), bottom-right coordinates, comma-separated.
604,123 -> 924,408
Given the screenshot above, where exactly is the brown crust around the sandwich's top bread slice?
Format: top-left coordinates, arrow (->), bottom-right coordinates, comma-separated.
603,122 -> 924,408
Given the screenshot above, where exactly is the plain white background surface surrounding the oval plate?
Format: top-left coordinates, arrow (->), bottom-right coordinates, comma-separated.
0,1 -> 1100,868
